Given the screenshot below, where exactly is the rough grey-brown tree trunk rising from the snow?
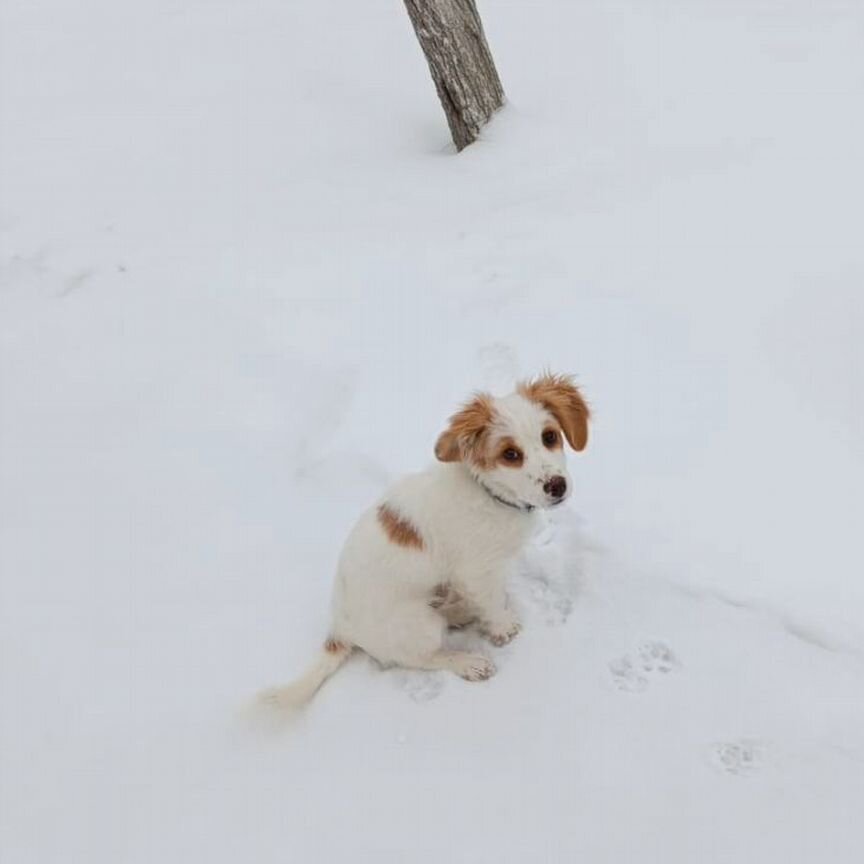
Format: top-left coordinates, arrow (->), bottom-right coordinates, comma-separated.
405,0 -> 504,150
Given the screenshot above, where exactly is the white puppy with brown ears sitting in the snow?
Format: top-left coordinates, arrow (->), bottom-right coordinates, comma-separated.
265,375 -> 589,707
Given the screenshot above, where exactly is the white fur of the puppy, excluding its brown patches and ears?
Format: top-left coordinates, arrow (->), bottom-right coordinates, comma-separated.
260,393 -> 570,706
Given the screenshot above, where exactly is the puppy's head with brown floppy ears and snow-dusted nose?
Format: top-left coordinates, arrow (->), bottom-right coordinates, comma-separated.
435,375 -> 590,507
